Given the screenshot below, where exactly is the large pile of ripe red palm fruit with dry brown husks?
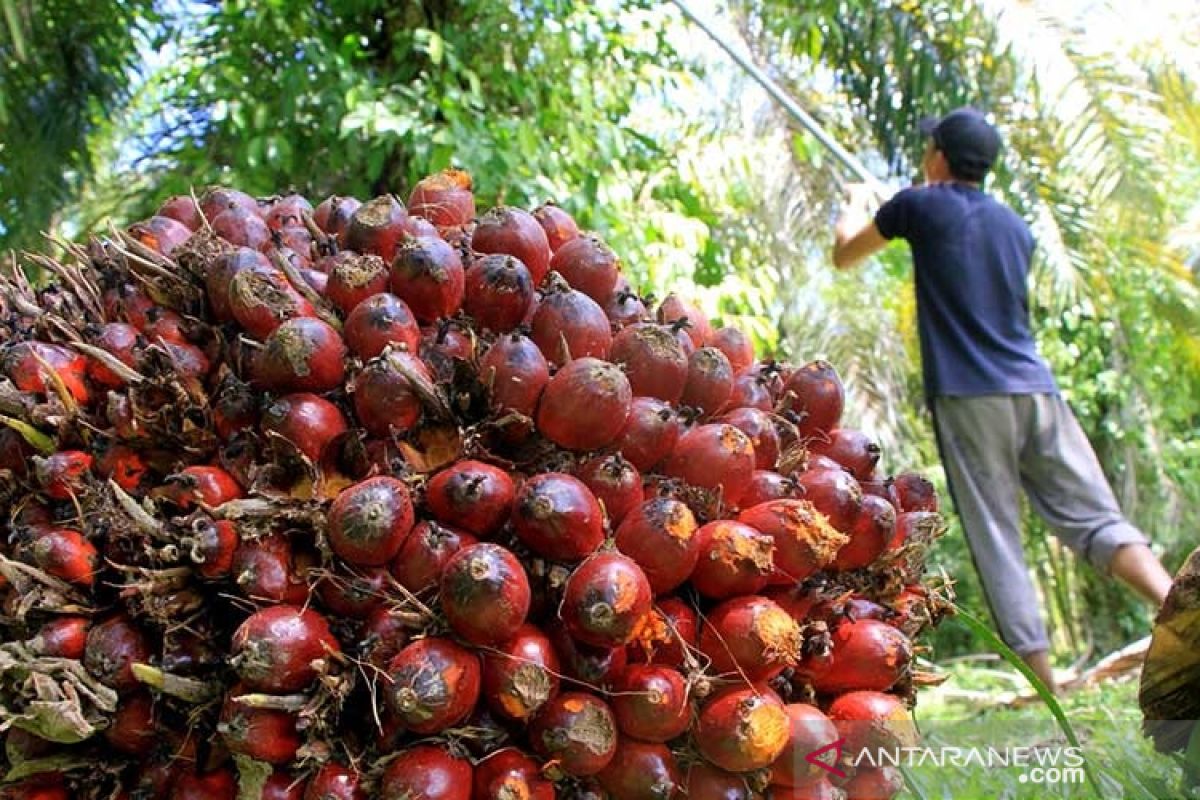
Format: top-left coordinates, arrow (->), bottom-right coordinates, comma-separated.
0,170 -> 948,800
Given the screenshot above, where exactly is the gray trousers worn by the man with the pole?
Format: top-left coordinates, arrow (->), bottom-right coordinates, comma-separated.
930,395 -> 1148,656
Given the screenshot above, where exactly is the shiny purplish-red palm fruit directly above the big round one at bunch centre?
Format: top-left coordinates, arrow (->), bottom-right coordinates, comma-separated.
532,278 -> 612,365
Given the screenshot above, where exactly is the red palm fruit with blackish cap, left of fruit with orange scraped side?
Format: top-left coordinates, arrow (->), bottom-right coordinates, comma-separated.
442,542 -> 530,645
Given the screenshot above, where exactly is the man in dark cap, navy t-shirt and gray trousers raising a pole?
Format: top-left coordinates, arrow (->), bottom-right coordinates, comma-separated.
833,108 -> 1171,690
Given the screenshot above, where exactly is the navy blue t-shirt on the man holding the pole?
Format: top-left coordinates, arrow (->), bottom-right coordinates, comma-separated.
875,184 -> 1057,397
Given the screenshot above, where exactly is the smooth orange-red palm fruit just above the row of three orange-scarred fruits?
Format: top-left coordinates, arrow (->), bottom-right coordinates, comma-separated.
664,423 -> 755,506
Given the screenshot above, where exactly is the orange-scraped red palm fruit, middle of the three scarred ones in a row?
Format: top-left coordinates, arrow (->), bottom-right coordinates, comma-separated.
691,519 -> 775,600
